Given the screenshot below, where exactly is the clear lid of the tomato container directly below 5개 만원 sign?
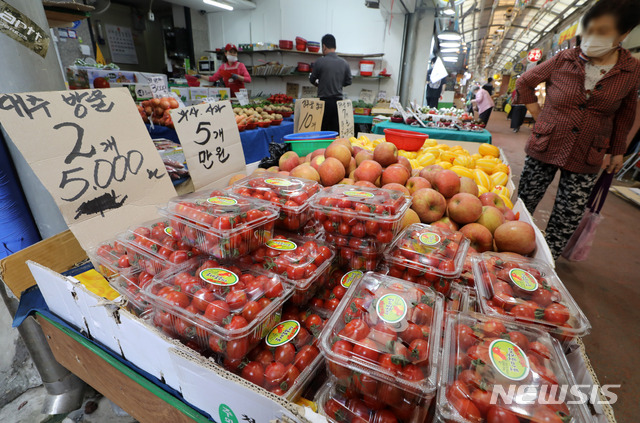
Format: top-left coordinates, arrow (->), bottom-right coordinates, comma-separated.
165,191 -> 279,237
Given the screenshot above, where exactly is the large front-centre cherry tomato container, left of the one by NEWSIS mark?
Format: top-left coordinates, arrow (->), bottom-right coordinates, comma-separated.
320,272 -> 443,422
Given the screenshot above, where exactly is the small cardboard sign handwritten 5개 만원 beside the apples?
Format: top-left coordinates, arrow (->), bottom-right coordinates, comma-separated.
169,100 -> 246,190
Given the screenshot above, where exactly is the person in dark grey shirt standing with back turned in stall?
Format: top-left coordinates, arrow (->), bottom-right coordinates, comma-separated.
309,34 -> 351,132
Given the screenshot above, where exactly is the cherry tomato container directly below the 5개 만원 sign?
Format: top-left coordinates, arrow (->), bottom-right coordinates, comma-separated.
160,191 -> 280,259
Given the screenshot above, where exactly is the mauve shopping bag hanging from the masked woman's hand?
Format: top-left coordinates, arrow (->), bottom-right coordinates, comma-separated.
562,172 -> 613,261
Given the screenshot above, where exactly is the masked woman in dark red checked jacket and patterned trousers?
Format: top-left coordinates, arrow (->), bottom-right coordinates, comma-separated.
515,0 -> 640,259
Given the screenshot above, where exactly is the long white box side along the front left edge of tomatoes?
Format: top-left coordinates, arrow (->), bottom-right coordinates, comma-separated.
27,261 -> 314,423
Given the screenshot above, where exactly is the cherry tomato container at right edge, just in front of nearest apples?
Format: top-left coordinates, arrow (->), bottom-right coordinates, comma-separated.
474,253 -> 591,345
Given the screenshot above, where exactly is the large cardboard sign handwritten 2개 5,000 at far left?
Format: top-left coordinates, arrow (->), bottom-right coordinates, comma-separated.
0,88 -> 176,249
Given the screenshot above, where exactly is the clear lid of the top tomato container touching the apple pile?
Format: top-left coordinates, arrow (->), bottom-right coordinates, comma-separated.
311,185 -> 411,224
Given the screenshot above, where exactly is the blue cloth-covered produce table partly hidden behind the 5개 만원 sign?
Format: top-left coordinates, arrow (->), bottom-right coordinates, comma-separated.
146,119 -> 293,163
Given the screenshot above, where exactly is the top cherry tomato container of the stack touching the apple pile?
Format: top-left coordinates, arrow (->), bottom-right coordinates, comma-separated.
311,185 -> 411,244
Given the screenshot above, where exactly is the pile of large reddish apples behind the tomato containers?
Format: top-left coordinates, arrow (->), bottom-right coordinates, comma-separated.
248,138 -> 536,255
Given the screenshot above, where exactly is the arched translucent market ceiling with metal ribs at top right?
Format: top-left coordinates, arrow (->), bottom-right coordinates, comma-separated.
457,0 -> 590,72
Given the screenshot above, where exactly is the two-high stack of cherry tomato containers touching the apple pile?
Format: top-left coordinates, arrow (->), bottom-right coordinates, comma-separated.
311,185 -> 411,270
